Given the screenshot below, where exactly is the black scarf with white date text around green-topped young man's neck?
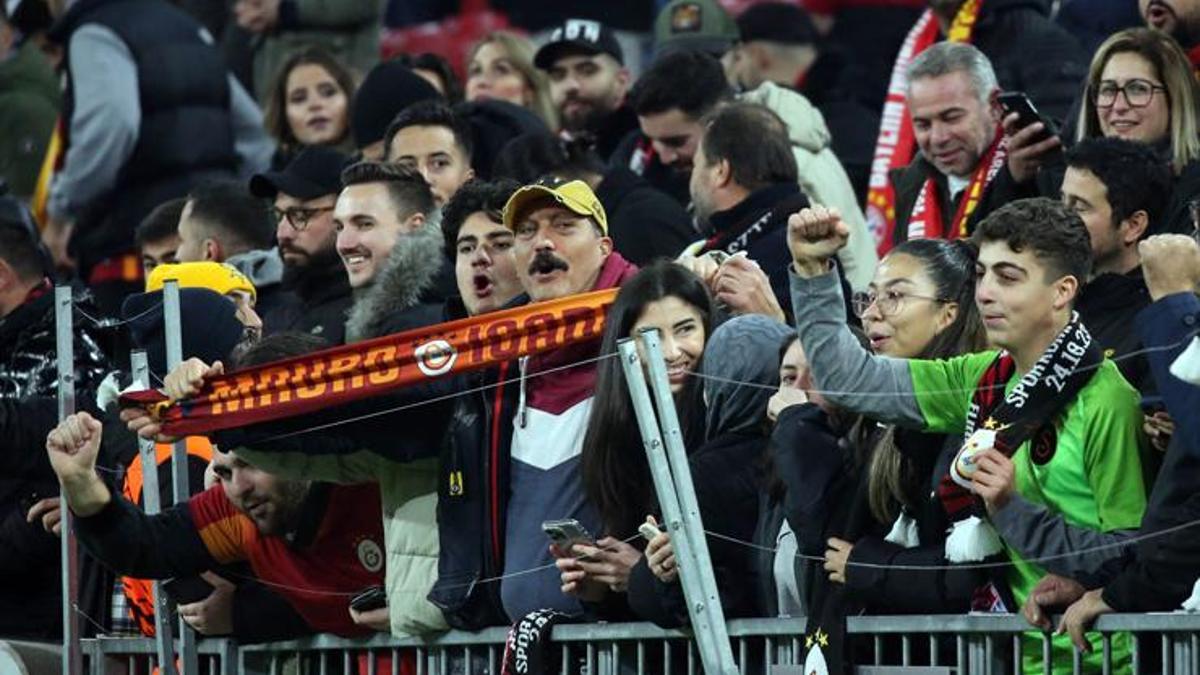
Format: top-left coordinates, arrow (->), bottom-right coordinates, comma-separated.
937,312 -> 1103,562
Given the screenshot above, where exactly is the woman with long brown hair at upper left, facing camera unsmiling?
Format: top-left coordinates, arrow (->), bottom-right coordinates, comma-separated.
264,47 -> 358,166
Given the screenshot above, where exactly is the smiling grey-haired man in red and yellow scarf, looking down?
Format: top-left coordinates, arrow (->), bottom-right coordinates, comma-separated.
889,42 -> 1016,244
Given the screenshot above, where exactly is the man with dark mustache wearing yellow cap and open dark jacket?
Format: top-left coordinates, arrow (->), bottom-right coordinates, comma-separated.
430,178 -> 637,629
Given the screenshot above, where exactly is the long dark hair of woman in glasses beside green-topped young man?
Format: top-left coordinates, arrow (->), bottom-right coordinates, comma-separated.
853,239 -> 986,524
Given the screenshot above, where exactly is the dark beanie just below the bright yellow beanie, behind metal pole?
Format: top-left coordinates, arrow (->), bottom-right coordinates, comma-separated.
121,288 -> 245,378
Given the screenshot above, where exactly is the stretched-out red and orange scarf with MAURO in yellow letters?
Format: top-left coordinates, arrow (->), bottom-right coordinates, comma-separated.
121,288 -> 617,436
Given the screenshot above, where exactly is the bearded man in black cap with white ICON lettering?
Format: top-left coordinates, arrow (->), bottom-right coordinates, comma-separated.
533,19 -> 637,160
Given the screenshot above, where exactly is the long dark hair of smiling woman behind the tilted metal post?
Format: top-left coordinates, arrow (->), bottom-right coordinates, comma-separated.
581,261 -> 713,538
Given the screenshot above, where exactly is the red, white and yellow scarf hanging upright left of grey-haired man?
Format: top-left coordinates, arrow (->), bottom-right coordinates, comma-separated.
866,0 -> 984,256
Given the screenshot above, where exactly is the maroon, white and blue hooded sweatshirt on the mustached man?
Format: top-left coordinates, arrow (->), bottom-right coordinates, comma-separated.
500,252 -> 637,621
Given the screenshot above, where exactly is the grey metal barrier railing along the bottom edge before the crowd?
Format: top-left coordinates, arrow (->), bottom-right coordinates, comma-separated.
84,614 -> 1200,675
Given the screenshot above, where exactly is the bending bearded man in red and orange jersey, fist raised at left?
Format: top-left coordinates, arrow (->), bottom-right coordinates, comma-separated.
46,389 -> 384,637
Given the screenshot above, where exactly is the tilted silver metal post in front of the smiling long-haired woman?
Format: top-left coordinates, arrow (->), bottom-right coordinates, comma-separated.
617,333 -> 738,674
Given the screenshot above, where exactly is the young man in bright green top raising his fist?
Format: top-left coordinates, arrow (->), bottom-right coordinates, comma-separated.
788,199 -> 1146,671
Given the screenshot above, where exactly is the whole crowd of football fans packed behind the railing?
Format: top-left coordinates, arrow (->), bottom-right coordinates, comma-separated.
0,0 -> 1200,671
